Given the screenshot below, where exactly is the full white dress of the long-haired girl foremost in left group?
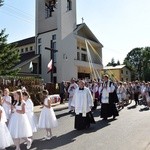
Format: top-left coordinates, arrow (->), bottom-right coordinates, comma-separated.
8,101 -> 32,139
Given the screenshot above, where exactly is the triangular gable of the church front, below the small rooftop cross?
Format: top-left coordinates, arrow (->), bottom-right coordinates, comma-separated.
74,23 -> 103,46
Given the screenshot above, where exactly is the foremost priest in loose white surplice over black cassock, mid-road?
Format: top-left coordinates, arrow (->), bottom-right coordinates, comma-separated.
71,80 -> 95,130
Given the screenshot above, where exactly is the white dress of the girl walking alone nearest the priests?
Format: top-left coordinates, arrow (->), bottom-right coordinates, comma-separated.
38,98 -> 58,129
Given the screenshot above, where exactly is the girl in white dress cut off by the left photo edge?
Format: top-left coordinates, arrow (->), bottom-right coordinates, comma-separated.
0,96 -> 14,149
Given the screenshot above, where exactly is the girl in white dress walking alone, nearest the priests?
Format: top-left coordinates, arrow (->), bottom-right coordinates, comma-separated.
38,90 -> 58,140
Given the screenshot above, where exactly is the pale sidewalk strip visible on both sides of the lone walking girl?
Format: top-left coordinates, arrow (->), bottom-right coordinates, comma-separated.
34,102 -> 68,113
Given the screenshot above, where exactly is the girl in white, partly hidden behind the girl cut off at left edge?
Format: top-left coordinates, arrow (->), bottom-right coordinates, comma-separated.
2,88 -> 12,120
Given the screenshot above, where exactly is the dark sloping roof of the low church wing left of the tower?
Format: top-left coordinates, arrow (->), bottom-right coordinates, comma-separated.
11,36 -> 35,47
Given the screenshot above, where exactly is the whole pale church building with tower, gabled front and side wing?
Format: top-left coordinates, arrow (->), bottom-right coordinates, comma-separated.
12,0 -> 103,83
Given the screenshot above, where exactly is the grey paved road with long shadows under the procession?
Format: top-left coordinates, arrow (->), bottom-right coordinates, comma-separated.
9,104 -> 150,150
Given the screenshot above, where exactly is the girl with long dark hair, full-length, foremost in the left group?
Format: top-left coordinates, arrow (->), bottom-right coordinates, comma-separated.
8,90 -> 32,150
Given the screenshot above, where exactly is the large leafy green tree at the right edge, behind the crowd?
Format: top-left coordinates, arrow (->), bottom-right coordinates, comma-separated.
124,47 -> 150,81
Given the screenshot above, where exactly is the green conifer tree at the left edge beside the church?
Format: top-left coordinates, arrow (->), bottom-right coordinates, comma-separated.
0,30 -> 20,75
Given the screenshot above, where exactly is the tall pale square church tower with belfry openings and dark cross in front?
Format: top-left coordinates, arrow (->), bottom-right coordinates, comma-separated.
35,0 -> 77,82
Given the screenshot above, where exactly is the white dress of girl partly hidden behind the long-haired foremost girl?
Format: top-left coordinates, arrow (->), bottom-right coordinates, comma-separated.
25,99 -> 37,132
